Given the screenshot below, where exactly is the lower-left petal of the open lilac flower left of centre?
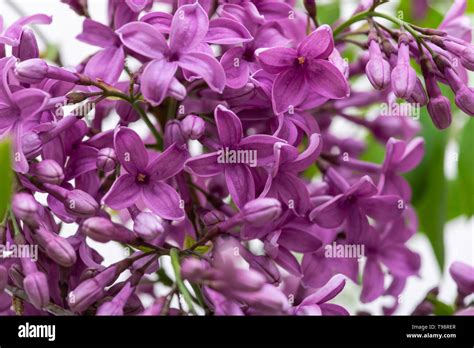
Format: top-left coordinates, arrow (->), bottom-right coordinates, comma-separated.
103,174 -> 140,210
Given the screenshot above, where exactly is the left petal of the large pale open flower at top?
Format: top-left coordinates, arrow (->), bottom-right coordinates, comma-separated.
116,22 -> 168,59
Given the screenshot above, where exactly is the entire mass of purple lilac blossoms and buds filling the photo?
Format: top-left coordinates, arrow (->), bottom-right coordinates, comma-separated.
0,0 -> 474,315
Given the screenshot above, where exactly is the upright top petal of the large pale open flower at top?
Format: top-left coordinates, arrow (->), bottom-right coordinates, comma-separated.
170,1 -> 209,53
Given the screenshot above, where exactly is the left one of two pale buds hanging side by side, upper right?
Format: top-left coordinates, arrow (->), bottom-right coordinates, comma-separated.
365,40 -> 390,90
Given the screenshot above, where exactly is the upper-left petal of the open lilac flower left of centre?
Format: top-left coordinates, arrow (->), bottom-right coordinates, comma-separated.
114,127 -> 148,175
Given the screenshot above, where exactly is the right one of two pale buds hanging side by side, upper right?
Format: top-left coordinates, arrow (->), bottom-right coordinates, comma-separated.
391,41 -> 416,99
